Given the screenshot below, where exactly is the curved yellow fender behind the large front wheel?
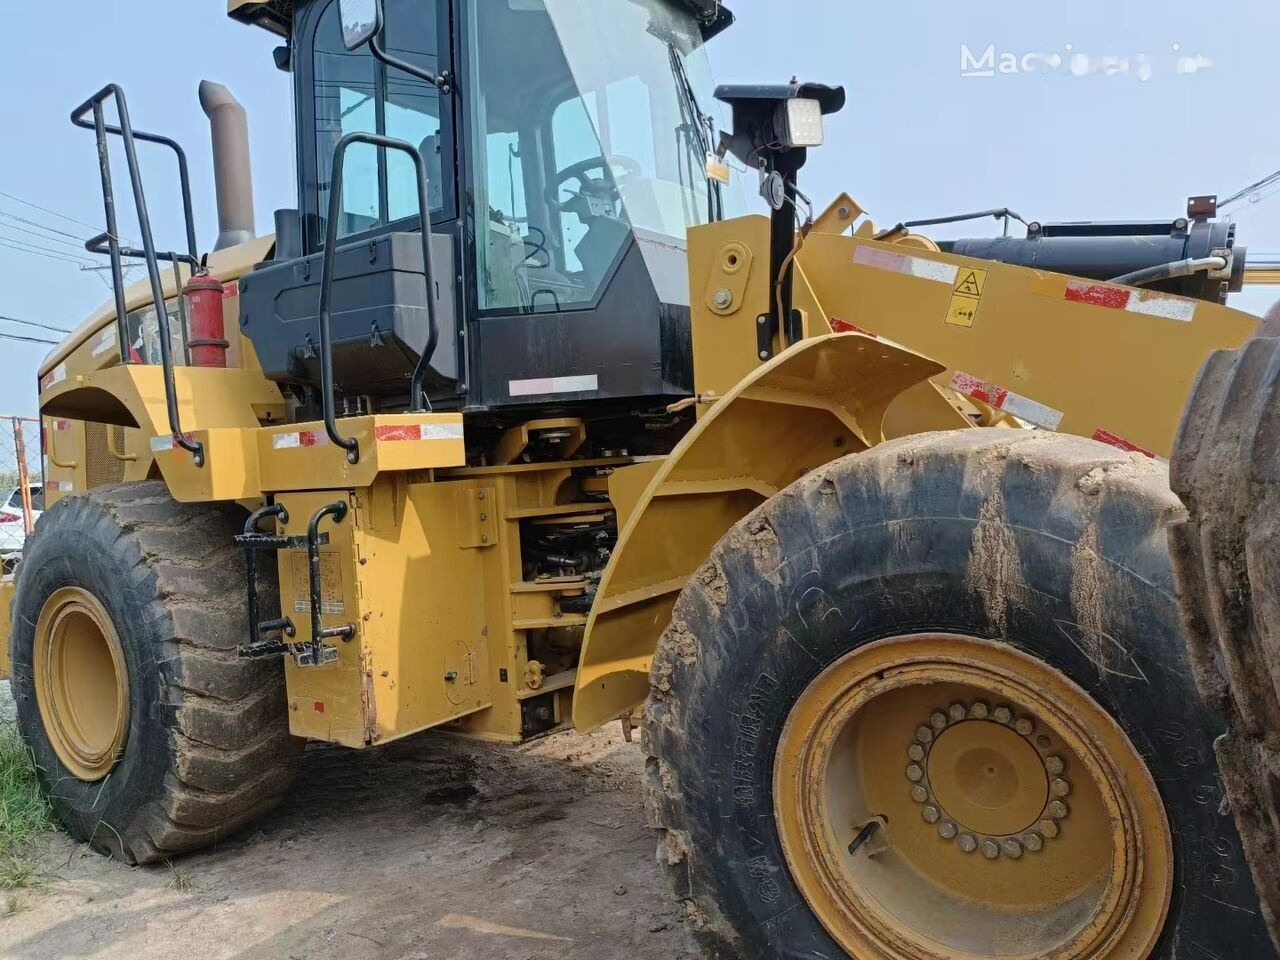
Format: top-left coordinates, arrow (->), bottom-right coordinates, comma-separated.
573,333 -> 945,730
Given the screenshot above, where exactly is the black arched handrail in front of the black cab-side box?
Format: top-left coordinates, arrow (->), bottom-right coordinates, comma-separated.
320,131 -> 440,463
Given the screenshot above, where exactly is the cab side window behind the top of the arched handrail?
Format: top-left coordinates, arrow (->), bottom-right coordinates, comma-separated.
314,0 -> 452,244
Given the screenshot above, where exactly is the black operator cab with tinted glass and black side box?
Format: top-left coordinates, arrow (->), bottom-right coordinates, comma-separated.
233,0 -> 745,422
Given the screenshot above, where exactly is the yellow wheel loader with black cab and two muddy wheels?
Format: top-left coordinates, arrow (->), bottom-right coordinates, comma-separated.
0,0 -> 1275,960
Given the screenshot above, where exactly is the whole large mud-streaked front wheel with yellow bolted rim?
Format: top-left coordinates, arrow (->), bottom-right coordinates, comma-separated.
645,430 -> 1272,960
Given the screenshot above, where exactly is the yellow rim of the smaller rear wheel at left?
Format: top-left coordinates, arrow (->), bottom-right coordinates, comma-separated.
33,586 -> 129,781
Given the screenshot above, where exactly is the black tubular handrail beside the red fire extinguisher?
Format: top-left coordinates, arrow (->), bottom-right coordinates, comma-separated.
72,83 -> 205,467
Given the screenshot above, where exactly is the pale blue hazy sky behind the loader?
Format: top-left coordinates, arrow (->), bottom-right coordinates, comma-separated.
0,0 -> 1280,415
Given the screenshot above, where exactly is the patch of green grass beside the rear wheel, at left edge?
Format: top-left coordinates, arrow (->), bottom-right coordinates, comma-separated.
0,718 -> 52,896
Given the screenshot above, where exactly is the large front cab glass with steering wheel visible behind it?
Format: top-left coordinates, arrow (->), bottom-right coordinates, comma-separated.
467,0 -> 745,311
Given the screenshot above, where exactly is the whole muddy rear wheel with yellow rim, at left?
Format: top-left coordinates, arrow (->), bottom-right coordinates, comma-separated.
10,481 -> 302,863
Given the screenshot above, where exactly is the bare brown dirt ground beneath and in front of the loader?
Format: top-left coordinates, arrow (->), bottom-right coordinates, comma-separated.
0,684 -> 695,960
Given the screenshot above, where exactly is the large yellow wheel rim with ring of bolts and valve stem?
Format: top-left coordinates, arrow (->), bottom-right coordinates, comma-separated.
774,634 -> 1172,960
